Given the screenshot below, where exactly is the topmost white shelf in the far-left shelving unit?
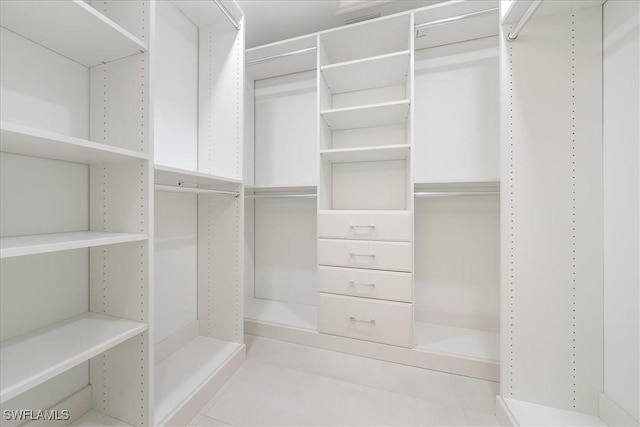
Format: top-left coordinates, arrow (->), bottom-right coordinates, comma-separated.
0,0 -> 148,67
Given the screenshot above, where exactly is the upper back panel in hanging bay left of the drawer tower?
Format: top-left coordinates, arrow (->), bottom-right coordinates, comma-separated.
254,71 -> 318,186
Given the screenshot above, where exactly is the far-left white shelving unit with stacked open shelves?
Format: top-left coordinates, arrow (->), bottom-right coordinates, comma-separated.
0,1 -> 153,426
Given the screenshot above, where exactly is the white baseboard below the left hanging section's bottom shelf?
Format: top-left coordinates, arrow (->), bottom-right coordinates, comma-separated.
156,344 -> 246,427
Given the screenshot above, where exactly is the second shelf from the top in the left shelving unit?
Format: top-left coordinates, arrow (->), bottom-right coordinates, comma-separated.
0,122 -> 149,164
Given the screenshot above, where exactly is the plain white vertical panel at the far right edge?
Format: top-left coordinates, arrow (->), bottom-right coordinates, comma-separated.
603,0 -> 640,420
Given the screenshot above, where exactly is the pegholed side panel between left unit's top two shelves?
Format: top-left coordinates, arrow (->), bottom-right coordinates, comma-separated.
89,53 -> 151,153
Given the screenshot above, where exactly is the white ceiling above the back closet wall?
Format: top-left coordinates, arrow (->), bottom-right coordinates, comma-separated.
237,0 -> 443,48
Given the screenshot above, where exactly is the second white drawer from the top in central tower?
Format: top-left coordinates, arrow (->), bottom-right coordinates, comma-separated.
318,239 -> 413,272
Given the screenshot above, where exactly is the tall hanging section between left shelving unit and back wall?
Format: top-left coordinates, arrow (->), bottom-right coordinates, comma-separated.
152,1 -> 245,425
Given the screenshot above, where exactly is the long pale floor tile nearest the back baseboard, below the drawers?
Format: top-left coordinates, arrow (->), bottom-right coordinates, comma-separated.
245,334 -> 460,406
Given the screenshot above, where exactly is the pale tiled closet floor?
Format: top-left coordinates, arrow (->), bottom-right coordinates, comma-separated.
189,335 -> 498,427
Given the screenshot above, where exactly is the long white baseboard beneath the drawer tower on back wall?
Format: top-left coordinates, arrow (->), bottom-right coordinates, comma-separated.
244,319 -> 500,381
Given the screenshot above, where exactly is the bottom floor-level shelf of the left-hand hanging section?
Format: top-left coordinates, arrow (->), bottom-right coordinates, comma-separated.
154,336 -> 242,423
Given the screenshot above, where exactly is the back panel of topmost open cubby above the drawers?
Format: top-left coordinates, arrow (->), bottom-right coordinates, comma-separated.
320,14 -> 413,65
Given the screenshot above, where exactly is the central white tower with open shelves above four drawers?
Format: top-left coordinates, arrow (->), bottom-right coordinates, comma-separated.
318,14 -> 413,347
